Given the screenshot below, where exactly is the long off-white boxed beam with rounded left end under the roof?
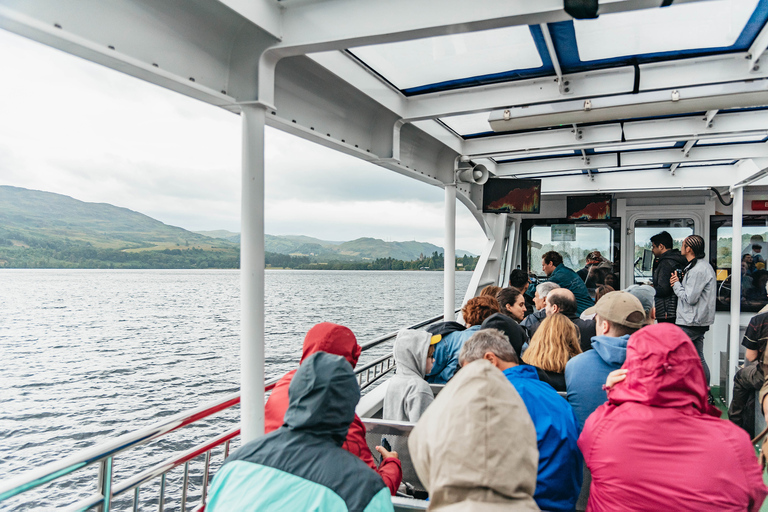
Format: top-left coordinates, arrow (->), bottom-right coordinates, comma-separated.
490,80 -> 768,132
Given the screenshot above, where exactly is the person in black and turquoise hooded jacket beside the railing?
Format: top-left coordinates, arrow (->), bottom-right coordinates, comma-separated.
206,352 -> 394,512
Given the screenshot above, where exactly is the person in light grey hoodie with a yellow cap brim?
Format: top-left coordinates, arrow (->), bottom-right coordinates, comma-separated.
383,329 -> 440,423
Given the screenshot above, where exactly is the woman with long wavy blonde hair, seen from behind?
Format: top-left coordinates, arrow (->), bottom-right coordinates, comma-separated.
523,313 -> 581,391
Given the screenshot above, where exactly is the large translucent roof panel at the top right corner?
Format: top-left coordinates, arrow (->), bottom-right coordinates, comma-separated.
573,0 -> 758,61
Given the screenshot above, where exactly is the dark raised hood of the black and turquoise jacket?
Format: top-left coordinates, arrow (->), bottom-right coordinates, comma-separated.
284,352 -> 360,446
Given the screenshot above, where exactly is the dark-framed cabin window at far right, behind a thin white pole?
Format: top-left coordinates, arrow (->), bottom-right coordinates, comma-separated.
709,215 -> 768,312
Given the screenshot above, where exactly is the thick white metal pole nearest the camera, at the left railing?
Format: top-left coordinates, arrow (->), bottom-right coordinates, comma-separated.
240,105 -> 266,443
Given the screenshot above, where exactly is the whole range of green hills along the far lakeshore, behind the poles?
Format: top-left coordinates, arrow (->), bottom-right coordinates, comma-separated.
0,186 -> 475,268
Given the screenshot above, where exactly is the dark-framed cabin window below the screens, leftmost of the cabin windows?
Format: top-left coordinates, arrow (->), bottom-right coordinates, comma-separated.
522,219 -> 621,288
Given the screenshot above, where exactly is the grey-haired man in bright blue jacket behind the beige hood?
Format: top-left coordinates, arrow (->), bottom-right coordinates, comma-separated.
459,329 -> 583,512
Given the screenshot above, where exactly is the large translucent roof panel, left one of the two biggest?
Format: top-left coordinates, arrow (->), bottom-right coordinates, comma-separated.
350,26 -> 542,90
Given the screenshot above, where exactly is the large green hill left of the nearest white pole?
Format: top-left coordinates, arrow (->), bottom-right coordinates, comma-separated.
0,186 -> 239,268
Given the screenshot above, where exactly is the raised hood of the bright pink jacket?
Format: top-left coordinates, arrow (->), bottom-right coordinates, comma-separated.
608,323 -> 720,418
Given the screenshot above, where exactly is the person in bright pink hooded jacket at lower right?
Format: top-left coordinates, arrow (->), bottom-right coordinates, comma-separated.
579,323 -> 768,512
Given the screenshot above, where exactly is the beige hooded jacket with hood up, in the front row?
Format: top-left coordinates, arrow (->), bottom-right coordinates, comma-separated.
408,359 -> 539,511
